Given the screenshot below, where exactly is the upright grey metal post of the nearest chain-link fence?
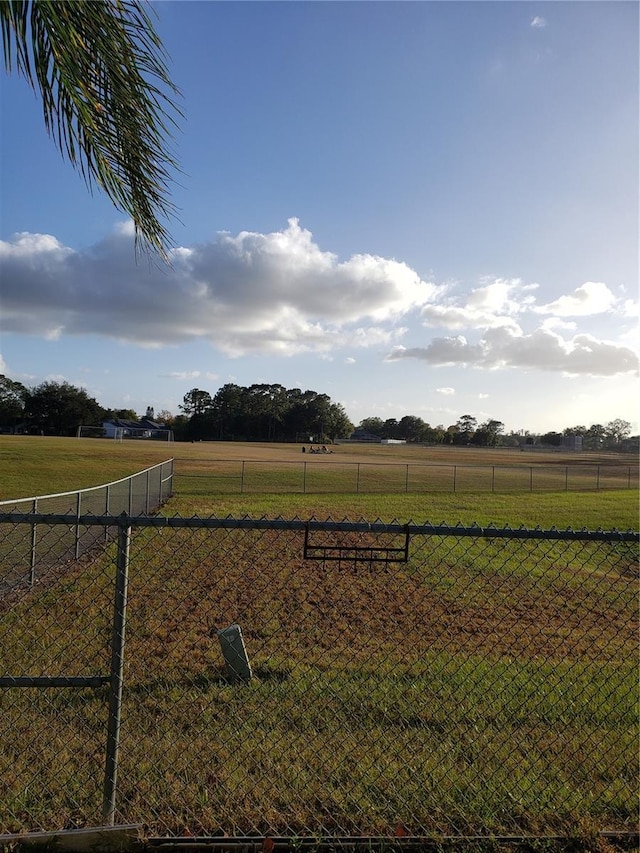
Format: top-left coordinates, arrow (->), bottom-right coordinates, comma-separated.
102,524 -> 131,826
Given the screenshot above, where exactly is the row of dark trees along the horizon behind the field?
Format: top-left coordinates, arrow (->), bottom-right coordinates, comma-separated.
0,375 -> 638,450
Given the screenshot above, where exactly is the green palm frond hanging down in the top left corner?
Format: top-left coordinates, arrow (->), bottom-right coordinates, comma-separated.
0,0 -> 180,259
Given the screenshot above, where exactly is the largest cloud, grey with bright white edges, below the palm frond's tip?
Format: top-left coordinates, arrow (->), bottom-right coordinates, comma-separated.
0,219 -> 439,356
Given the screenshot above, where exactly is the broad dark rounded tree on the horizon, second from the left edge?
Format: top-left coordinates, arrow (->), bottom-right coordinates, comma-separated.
24,382 -> 105,435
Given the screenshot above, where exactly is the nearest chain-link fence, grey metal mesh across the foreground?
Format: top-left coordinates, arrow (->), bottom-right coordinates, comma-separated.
0,513 -> 639,839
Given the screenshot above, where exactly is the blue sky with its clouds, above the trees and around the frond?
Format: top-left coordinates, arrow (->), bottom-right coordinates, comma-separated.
0,0 -> 639,431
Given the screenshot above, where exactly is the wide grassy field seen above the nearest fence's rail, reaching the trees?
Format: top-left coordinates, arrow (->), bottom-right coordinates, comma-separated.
0,436 -> 638,529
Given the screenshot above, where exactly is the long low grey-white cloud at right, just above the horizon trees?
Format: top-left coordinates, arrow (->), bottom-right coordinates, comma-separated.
387,328 -> 638,376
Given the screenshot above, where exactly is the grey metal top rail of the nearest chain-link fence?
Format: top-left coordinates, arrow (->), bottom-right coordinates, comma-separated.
0,512 -> 640,545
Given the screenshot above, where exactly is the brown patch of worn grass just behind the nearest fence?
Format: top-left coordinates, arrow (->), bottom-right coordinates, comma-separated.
124,532 -> 638,666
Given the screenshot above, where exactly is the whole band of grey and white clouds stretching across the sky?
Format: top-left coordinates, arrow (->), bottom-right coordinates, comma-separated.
0,219 -> 638,376
